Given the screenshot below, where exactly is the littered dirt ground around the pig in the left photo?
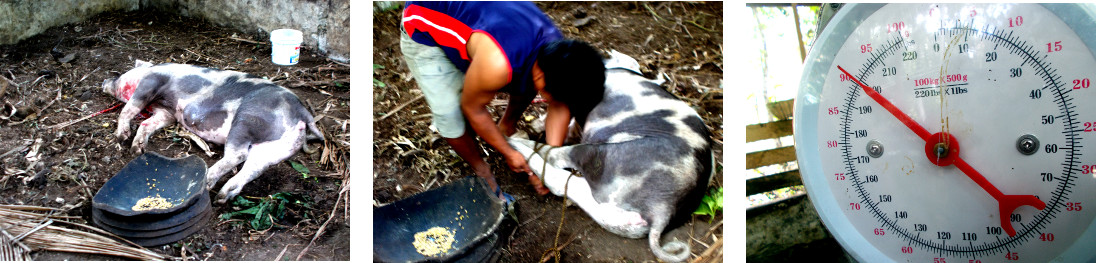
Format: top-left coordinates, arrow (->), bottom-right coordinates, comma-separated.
0,11 -> 350,261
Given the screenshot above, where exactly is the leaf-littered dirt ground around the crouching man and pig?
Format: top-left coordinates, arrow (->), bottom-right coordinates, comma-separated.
373,2 -> 723,262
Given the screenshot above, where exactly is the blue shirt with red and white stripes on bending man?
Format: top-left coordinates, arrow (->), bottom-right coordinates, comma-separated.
402,1 -> 563,93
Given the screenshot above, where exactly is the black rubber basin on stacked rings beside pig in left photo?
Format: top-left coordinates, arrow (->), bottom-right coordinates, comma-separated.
92,152 -> 206,217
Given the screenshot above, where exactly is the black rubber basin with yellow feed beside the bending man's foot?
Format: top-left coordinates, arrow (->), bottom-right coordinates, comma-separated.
373,176 -> 505,262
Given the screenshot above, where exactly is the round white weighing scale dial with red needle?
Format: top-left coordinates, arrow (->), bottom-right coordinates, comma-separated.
796,4 -> 1096,263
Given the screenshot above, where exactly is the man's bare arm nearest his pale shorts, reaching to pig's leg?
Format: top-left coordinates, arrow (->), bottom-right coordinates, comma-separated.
460,33 -> 532,175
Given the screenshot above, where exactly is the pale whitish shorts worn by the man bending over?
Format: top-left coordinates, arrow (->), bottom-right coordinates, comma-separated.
400,30 -> 467,138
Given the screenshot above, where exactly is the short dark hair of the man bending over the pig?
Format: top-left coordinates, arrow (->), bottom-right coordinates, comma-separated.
537,39 -> 605,125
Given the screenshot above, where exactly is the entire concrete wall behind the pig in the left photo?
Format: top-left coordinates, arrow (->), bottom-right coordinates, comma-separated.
0,0 -> 350,62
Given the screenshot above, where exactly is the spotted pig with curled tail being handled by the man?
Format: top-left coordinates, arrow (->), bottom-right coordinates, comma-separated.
510,50 -> 713,262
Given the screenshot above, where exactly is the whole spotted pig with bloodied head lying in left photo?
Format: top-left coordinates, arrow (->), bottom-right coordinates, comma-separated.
103,60 -> 323,204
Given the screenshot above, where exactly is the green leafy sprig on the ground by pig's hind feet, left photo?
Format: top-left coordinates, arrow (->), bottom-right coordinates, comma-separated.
220,192 -> 311,230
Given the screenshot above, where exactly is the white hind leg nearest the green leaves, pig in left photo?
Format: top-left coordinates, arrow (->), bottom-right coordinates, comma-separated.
217,121 -> 306,204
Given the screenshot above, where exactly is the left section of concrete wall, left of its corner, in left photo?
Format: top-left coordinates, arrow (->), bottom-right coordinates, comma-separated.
0,0 -> 140,45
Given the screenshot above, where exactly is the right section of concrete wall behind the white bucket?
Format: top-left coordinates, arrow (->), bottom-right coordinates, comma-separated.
142,0 -> 350,62
